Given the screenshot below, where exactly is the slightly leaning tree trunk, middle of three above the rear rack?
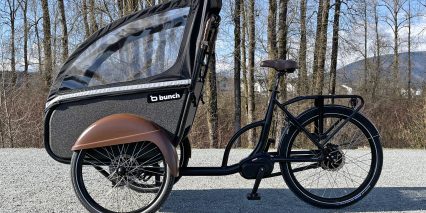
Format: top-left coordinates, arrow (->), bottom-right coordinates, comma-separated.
315,0 -> 330,95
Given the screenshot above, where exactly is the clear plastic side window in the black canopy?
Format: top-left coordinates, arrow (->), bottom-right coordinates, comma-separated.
61,8 -> 189,90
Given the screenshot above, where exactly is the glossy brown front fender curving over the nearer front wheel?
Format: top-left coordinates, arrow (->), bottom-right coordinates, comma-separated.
72,114 -> 179,177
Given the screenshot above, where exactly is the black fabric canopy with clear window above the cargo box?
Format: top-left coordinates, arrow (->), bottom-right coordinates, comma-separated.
49,0 -> 221,100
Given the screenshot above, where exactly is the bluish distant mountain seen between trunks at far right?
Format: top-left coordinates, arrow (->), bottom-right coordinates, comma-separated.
337,51 -> 426,88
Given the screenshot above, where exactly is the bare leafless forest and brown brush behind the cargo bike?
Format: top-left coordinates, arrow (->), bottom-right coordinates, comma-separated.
0,0 -> 426,149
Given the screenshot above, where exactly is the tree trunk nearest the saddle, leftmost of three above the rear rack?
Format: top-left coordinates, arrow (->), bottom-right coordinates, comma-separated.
297,0 -> 309,95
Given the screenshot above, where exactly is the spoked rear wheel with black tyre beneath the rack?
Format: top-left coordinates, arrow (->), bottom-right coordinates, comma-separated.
279,106 -> 383,208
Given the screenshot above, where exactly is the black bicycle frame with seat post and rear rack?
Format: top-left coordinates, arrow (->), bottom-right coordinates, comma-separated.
180,72 -> 364,177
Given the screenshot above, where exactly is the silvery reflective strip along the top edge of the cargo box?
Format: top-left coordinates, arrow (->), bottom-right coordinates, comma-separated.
46,79 -> 191,109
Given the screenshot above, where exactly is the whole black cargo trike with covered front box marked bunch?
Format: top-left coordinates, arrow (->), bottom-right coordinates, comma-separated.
44,0 -> 383,212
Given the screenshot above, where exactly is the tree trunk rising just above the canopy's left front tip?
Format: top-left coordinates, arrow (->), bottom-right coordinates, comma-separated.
41,0 -> 52,89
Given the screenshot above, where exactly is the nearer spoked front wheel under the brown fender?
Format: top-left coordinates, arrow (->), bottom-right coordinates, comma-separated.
71,142 -> 174,212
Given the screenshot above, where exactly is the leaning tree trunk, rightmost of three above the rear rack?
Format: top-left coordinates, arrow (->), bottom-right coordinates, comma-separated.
329,0 -> 342,95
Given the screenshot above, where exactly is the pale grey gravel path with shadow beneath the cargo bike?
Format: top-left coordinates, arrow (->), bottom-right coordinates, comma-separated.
0,149 -> 426,212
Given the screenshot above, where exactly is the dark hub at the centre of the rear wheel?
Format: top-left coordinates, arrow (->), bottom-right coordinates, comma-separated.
321,144 -> 345,171
